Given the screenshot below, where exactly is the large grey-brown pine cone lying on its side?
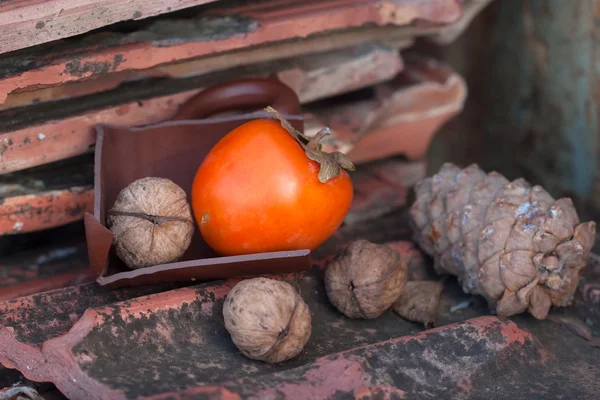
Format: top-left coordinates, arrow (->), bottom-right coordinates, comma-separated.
410,163 -> 596,319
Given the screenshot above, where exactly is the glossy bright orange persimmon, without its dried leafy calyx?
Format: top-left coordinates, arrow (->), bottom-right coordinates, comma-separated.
191,119 -> 353,256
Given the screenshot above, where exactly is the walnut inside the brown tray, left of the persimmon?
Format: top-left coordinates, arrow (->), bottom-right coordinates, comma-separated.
107,177 -> 195,269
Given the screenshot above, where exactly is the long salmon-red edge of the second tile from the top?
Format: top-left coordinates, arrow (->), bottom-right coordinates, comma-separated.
0,0 -> 461,102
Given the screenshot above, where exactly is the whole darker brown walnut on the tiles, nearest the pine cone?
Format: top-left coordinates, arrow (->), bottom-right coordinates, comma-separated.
325,240 -> 407,319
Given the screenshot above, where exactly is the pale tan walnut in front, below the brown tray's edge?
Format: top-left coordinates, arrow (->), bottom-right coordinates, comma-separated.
223,278 -> 311,363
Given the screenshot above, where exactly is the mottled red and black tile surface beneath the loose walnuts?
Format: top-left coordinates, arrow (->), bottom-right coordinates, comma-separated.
0,210 -> 600,399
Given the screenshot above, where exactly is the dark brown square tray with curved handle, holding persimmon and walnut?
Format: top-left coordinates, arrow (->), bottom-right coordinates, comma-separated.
84,78 -> 311,287
